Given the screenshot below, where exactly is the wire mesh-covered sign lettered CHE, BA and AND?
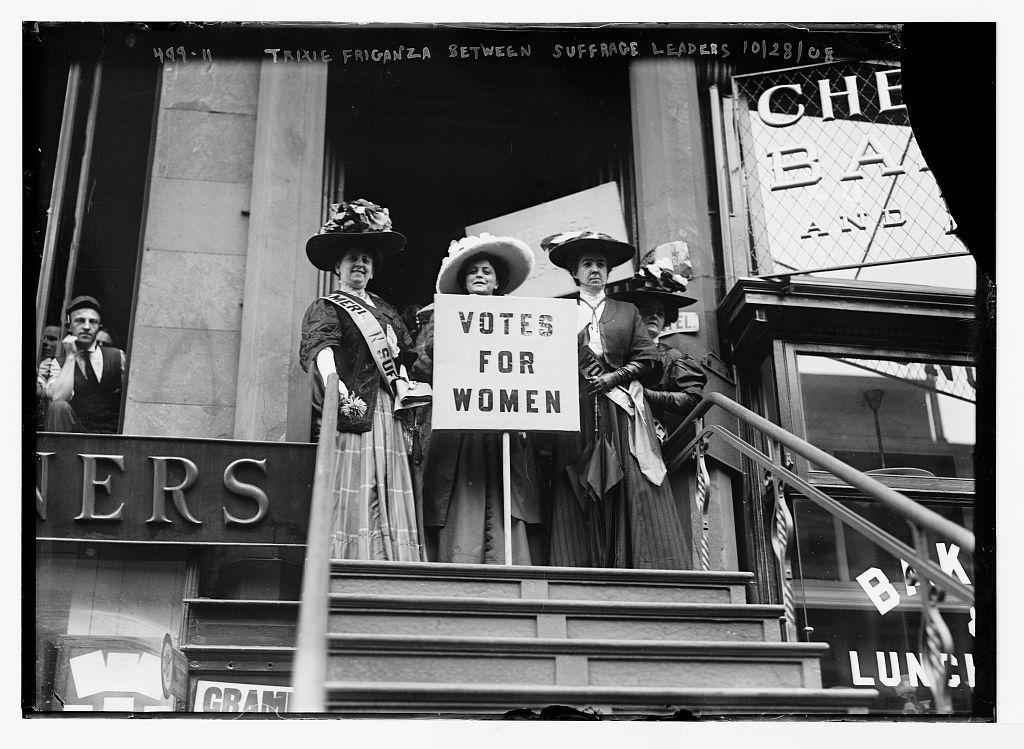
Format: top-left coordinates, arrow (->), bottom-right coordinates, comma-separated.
732,61 -> 967,276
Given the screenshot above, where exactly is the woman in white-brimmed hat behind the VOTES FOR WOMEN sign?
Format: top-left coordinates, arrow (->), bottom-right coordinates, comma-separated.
414,234 -> 543,565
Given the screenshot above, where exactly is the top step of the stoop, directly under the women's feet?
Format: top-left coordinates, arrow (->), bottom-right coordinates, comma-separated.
331,559 -> 754,604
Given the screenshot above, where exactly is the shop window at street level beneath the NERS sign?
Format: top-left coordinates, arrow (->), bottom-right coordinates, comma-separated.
35,544 -> 186,712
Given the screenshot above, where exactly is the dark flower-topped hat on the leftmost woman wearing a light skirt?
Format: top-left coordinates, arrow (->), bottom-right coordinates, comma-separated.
306,199 -> 406,272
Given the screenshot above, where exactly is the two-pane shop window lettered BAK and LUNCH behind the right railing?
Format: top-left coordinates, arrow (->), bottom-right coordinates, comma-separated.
788,346 -> 975,714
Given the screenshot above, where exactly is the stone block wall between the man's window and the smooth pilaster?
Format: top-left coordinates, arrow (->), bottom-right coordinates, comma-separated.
124,60 -> 260,438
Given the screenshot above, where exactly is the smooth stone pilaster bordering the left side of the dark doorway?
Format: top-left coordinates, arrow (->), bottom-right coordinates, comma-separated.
234,60 -> 328,442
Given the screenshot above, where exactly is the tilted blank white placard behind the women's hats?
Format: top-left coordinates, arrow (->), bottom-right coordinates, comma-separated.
466,182 -> 634,296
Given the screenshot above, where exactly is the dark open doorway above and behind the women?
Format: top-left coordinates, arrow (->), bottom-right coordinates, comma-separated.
328,53 -> 633,308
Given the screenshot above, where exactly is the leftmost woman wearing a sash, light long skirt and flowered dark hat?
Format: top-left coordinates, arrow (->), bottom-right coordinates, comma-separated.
299,200 -> 423,561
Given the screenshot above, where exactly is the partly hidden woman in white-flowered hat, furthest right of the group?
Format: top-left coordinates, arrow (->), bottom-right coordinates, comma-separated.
610,259 -> 708,442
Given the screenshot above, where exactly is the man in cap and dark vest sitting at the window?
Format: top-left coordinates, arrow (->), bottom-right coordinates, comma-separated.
46,296 -> 125,433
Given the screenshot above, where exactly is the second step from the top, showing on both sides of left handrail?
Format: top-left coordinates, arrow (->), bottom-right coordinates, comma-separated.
186,595 -> 782,646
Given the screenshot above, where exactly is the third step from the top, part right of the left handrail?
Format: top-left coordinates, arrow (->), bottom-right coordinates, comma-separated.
328,634 -> 828,689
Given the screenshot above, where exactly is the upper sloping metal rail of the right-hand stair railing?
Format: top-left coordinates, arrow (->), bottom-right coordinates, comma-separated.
667,392 -> 975,553
